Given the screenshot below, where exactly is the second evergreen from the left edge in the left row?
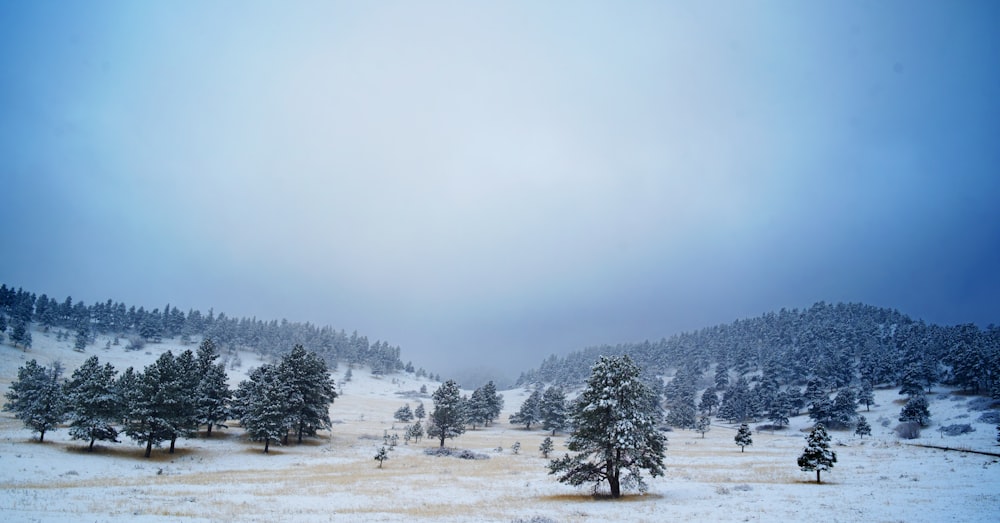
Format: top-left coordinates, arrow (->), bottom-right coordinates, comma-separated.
65,356 -> 121,451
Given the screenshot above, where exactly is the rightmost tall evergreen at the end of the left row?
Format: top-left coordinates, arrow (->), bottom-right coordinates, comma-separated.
278,345 -> 337,443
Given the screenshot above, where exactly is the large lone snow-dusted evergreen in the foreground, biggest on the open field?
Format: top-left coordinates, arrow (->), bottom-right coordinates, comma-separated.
549,355 -> 666,498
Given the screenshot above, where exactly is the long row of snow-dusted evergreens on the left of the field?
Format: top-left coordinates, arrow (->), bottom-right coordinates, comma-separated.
4,340 -> 337,458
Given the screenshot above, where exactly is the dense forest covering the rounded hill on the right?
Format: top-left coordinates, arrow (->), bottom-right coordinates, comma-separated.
517,302 -> 1000,398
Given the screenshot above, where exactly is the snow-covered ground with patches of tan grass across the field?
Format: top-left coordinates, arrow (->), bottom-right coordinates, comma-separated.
0,331 -> 1000,522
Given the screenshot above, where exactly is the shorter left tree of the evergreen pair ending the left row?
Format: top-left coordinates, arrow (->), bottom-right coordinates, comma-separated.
233,365 -> 291,454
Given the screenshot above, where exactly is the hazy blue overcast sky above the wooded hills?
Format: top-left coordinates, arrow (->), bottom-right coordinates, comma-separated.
0,0 -> 1000,376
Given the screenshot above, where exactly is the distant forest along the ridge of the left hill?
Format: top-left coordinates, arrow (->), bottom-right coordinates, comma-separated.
0,284 -> 422,377
